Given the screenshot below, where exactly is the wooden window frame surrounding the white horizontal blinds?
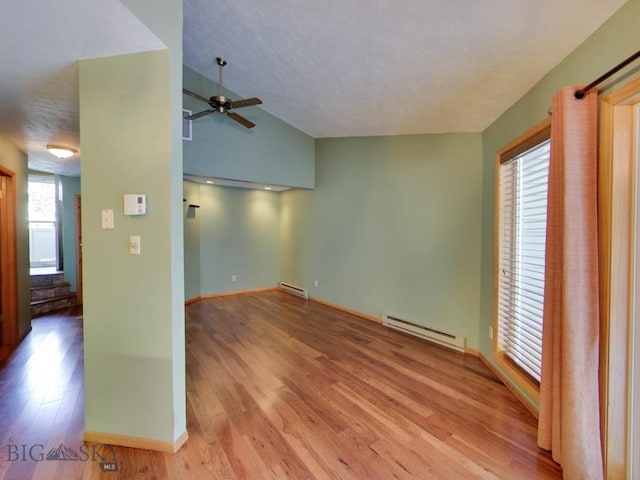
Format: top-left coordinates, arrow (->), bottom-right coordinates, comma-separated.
493,118 -> 551,404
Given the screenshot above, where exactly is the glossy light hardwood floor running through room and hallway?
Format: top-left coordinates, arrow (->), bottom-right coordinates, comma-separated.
0,291 -> 562,480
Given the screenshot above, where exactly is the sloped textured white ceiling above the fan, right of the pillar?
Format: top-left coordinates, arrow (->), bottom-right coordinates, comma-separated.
184,0 -> 625,138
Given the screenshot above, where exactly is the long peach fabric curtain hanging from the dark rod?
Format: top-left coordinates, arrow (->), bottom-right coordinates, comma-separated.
538,87 -> 603,480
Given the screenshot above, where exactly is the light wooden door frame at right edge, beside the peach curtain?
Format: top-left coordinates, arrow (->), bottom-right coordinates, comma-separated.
598,75 -> 640,478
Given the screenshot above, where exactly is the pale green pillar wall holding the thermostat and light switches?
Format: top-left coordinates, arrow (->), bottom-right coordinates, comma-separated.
79,0 -> 186,443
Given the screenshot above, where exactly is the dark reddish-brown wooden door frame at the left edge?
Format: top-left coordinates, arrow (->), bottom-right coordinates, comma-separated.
0,165 -> 19,347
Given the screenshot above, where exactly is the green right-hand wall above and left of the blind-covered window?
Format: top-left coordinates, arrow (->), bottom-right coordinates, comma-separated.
479,0 -> 640,398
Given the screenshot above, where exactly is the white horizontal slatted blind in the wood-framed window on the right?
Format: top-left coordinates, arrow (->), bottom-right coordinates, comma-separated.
498,140 -> 550,382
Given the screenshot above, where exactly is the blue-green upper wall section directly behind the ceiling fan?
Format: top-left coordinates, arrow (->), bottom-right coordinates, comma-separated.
183,65 -> 314,188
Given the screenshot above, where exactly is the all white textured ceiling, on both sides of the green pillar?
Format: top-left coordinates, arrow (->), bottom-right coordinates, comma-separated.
0,0 -> 625,175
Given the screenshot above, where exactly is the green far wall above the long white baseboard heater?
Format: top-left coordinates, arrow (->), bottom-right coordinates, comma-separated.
281,134 -> 482,348
